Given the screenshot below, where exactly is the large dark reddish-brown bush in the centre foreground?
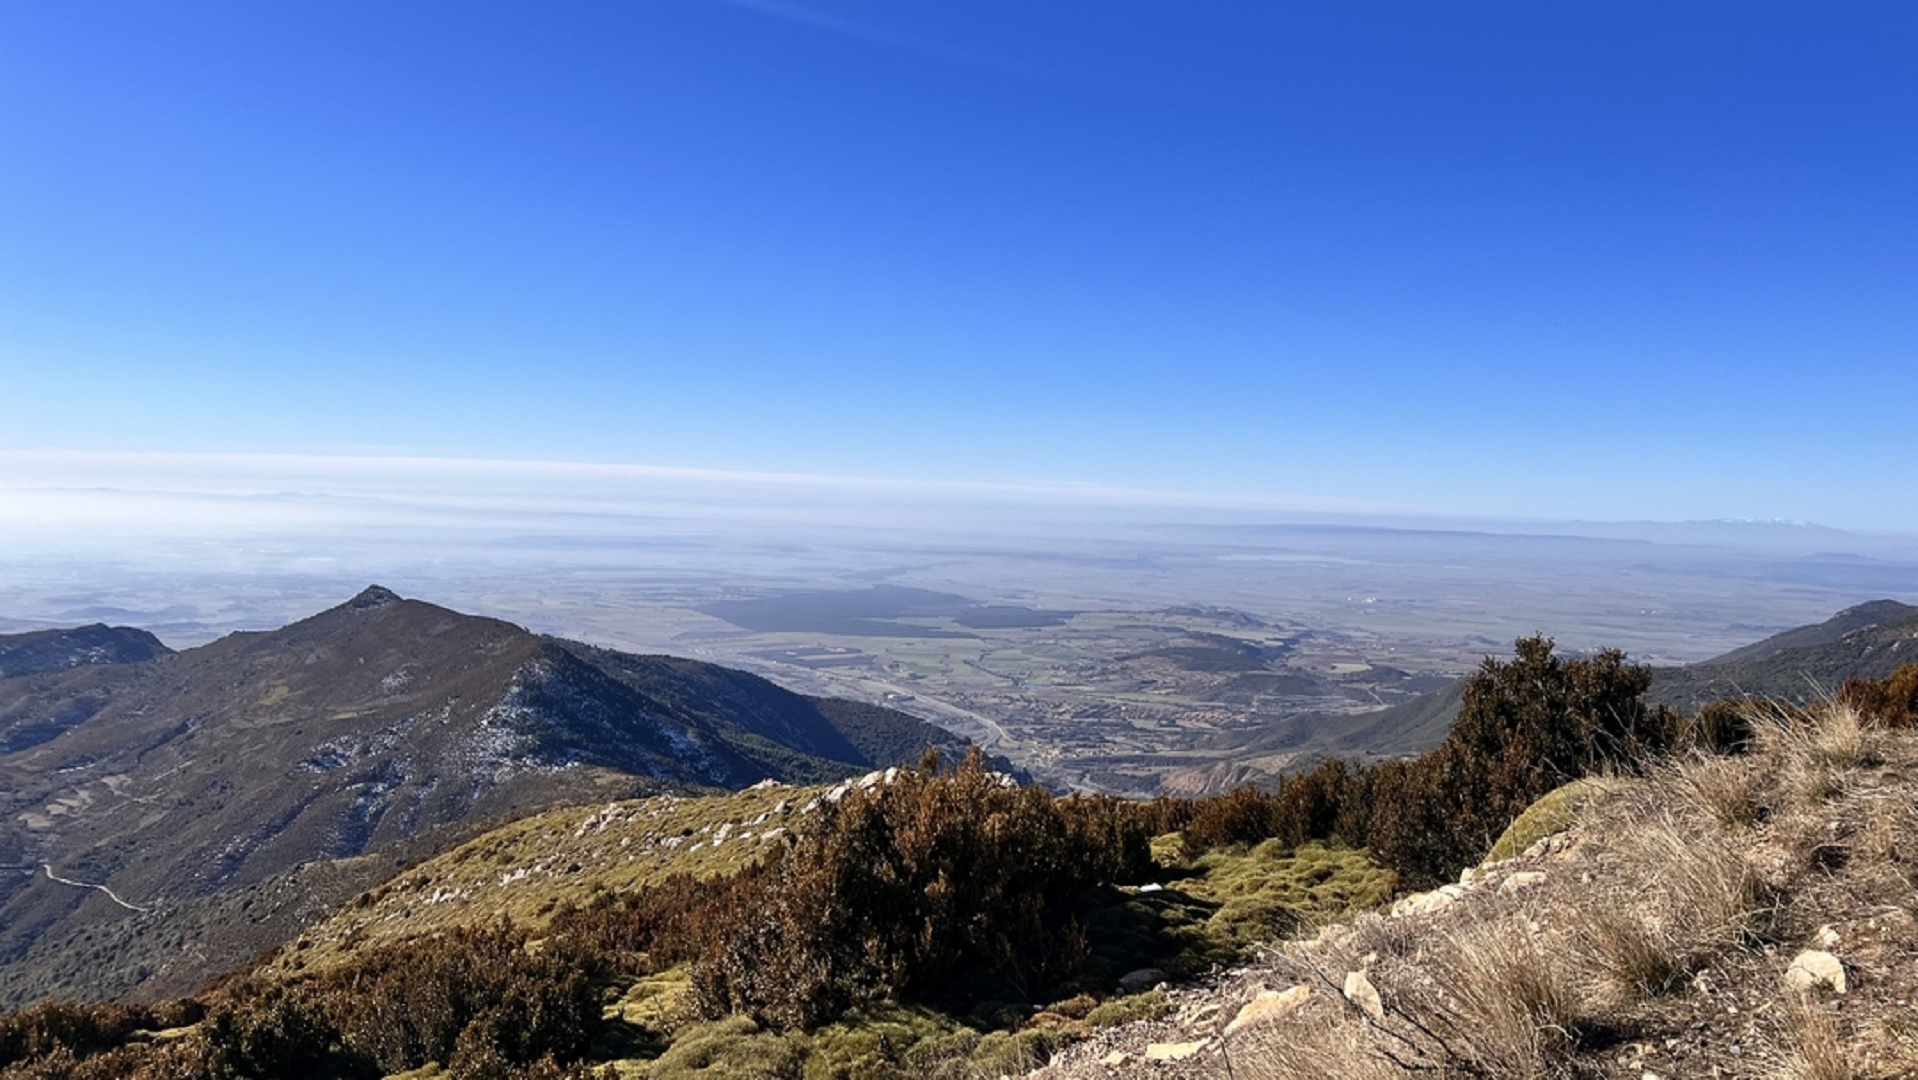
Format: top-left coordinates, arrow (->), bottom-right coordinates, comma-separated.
692,754 -> 1151,1028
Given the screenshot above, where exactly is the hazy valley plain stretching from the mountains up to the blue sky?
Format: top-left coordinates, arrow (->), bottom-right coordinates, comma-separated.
0,455 -> 1918,794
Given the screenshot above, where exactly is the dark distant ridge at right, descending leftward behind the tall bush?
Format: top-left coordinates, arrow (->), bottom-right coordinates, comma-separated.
1164,600 -> 1918,794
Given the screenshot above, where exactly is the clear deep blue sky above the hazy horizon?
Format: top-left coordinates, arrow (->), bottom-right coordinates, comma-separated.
0,0 -> 1918,531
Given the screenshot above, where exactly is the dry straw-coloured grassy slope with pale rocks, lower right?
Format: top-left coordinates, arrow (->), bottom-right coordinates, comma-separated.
1043,668 -> 1918,1080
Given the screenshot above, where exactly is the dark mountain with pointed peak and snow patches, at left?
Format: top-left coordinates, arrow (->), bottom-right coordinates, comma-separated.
0,587 -> 965,1007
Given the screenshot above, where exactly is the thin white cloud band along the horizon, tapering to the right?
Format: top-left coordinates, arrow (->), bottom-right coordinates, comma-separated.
0,451 -> 1364,548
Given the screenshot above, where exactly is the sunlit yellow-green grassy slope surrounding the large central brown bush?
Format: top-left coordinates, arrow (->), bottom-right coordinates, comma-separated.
261,777 -> 1392,1078
